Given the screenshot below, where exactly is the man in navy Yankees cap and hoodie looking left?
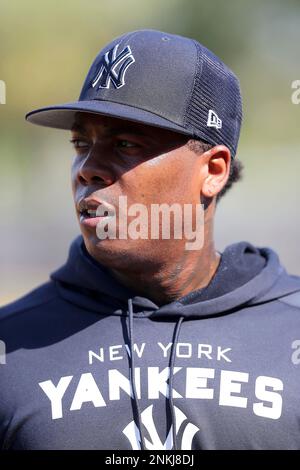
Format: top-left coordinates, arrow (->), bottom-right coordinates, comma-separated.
0,31 -> 300,450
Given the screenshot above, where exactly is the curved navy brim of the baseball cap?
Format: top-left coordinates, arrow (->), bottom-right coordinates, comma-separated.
26,100 -> 191,135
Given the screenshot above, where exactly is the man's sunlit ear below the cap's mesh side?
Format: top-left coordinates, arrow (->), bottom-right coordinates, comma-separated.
201,145 -> 231,198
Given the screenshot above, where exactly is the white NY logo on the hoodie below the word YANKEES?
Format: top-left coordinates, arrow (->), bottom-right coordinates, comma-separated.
123,405 -> 199,450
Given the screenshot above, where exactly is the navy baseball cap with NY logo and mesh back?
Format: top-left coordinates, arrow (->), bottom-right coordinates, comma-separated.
26,30 -> 242,157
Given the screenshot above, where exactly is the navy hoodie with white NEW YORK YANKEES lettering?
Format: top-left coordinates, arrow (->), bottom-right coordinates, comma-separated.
0,237 -> 300,450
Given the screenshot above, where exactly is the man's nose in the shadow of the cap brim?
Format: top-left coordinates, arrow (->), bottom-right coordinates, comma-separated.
76,149 -> 115,186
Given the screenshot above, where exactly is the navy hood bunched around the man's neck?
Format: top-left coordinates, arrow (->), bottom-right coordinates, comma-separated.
51,236 -> 300,318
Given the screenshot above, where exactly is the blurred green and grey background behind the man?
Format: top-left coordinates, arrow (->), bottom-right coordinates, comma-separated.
0,0 -> 300,304
